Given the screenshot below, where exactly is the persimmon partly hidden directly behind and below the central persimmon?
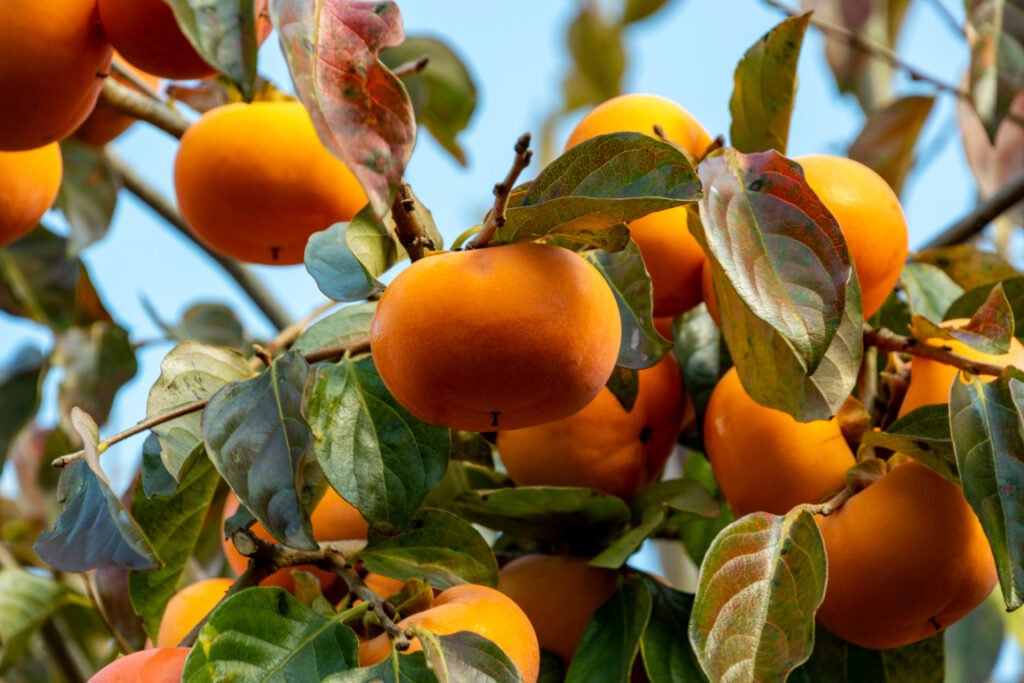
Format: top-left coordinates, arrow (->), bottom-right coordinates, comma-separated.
498,355 -> 684,498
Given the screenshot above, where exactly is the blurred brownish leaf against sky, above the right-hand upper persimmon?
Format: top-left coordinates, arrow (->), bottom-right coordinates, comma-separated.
847,95 -> 935,195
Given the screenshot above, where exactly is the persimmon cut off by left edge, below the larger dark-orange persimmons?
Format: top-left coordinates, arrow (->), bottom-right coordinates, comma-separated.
0,142 -> 63,247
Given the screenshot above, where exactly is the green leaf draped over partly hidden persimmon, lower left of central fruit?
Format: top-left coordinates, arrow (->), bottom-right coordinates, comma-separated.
358,509 -> 498,589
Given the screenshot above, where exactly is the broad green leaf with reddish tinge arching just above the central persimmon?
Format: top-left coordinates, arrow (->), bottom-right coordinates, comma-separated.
490,133 -> 700,245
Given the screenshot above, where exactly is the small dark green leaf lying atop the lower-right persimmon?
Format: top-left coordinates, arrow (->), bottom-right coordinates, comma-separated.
860,403 -> 959,484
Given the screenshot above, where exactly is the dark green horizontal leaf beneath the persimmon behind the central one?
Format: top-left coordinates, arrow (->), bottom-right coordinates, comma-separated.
456,486 -> 631,541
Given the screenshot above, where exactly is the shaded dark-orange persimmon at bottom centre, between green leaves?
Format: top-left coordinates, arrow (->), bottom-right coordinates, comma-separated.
498,555 -> 617,667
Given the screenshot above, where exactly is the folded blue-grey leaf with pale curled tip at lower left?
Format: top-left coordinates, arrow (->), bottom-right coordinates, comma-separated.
33,409 -> 160,572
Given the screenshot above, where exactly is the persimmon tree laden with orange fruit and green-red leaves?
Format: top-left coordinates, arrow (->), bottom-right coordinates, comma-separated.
0,0 -> 1024,683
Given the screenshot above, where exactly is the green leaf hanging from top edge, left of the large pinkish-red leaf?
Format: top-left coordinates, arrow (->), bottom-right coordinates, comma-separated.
168,0 -> 259,101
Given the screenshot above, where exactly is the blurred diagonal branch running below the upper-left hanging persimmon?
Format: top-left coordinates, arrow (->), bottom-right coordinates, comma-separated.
106,150 -> 291,330
